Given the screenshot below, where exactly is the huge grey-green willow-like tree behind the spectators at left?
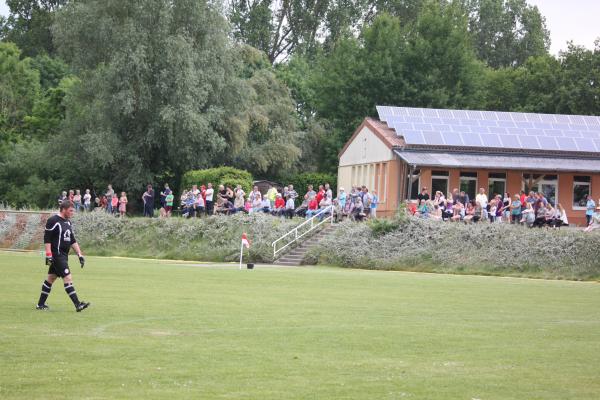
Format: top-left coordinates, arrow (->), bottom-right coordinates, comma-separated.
53,0 -> 243,188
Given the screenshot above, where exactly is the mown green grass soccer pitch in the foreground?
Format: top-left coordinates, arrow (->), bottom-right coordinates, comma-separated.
0,253 -> 600,400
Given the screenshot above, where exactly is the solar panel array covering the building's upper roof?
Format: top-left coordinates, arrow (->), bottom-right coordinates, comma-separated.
377,106 -> 600,153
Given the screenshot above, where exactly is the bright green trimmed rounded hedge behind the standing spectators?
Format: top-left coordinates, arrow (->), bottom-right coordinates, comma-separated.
181,167 -> 253,193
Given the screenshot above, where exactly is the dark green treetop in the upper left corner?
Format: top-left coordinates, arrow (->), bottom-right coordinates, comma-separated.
0,0 -> 68,57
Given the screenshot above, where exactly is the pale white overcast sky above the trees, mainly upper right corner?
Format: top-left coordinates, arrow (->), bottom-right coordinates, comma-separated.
0,0 -> 600,55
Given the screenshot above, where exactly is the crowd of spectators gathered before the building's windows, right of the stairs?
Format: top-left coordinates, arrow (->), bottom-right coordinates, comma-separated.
407,187 -> 572,228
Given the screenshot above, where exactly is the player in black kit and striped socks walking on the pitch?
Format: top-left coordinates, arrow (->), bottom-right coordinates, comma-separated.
35,200 -> 90,312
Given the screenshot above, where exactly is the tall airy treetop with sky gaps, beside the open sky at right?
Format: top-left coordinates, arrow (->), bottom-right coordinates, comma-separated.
465,0 -> 550,68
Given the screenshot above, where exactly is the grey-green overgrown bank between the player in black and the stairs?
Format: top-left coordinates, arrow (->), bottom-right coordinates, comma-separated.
74,213 -> 298,262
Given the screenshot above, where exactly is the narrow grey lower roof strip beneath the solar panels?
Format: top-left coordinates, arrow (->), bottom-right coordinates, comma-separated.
394,150 -> 600,172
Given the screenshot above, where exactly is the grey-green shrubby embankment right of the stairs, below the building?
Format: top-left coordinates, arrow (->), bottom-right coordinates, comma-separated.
308,217 -> 600,280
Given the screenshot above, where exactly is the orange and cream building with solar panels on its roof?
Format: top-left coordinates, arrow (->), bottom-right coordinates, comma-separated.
338,106 -> 600,225
